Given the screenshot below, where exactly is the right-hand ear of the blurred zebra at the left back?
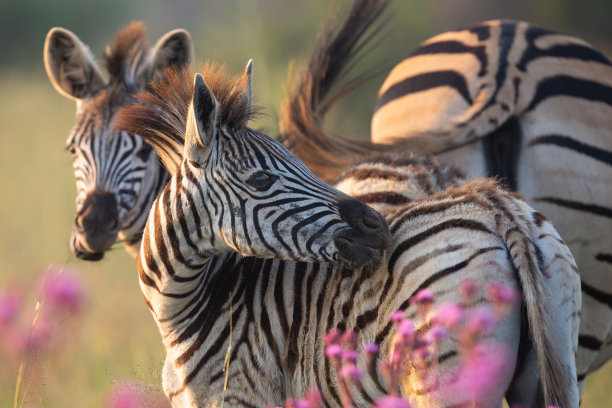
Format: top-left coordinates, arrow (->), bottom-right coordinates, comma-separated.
151,28 -> 193,73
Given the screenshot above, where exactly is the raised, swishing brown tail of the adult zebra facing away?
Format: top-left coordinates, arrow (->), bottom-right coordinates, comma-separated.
279,0 -> 398,182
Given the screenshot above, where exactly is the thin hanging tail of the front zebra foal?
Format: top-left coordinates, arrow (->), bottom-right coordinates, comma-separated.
497,186 -> 573,407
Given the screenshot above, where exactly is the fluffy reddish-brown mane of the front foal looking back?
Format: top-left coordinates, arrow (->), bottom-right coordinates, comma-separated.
114,62 -> 255,174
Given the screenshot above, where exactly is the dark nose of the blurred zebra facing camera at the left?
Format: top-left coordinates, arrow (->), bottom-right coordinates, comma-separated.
74,191 -> 119,252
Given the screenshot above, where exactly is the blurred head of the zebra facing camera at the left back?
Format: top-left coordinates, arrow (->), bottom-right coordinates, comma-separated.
44,22 -> 192,260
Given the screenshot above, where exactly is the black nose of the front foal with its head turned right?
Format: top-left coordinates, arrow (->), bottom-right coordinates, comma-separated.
338,198 -> 391,250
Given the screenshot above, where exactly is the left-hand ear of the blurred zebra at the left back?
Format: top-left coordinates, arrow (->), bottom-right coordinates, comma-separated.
43,27 -> 105,99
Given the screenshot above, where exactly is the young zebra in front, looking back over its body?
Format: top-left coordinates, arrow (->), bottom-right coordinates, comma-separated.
116,59 -> 580,407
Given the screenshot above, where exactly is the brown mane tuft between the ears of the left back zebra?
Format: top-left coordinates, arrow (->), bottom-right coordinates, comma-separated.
104,21 -> 150,85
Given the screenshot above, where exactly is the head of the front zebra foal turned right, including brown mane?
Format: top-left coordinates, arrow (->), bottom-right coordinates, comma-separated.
120,62 -> 390,267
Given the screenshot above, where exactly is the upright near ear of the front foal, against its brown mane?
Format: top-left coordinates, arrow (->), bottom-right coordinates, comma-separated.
185,73 -> 219,163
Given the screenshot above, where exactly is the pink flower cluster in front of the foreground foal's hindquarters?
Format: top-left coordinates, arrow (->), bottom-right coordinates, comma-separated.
286,280 -> 520,408
